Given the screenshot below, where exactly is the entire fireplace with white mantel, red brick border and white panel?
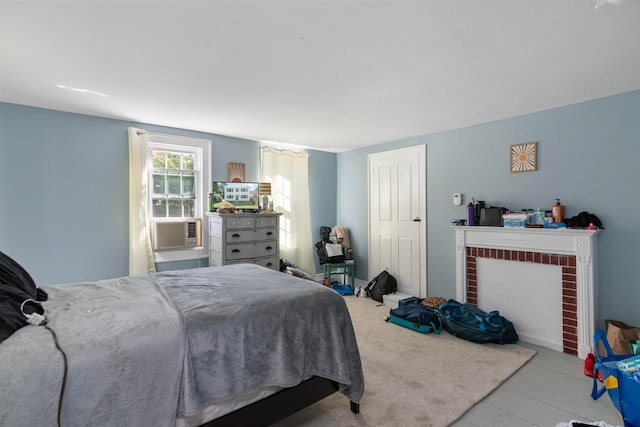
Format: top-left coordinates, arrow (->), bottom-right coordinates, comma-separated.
454,227 -> 598,358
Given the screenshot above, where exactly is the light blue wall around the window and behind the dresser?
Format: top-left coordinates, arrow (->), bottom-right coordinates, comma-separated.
0,103 -> 336,285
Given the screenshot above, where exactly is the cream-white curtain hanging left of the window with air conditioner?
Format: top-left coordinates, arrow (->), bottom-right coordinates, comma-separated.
129,128 -> 156,276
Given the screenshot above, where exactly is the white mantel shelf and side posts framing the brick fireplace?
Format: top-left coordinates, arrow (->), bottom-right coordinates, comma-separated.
452,226 -> 600,359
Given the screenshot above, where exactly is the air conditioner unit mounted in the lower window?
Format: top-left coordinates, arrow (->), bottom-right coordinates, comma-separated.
153,218 -> 202,251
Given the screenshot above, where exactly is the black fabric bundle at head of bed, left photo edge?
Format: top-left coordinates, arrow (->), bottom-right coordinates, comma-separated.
0,252 -> 48,343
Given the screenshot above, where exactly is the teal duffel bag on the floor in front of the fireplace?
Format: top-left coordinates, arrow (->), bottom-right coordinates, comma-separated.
438,299 -> 518,344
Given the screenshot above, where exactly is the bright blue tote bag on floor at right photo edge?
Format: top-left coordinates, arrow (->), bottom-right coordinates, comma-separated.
591,330 -> 640,427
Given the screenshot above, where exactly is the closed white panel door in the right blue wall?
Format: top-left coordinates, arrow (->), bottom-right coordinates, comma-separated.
368,145 -> 427,297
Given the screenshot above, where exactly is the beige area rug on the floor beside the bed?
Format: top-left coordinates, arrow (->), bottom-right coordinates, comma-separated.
276,296 -> 535,427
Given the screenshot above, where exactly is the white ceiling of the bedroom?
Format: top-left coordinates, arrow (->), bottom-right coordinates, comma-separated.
0,0 -> 640,152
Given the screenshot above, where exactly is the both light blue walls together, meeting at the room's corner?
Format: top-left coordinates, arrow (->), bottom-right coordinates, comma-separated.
0,92 -> 640,325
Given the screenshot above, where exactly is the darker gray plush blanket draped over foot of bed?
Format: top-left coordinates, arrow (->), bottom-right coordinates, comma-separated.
154,264 -> 364,416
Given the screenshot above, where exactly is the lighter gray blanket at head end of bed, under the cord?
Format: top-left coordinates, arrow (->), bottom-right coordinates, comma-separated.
0,276 -> 185,427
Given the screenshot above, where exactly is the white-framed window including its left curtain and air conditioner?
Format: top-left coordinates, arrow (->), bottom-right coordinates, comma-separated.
128,128 -> 212,275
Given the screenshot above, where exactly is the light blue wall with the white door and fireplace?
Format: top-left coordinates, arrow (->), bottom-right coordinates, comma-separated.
337,91 -> 640,326
